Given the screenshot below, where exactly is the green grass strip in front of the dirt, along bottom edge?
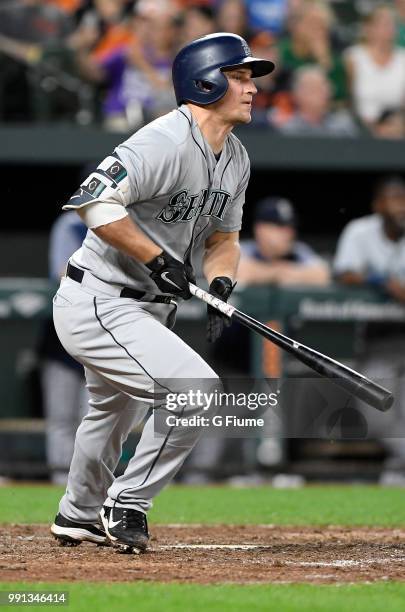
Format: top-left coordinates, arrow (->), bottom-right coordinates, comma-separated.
0,582 -> 405,612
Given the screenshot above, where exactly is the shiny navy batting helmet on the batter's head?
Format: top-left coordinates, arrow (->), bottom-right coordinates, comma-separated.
172,32 -> 274,106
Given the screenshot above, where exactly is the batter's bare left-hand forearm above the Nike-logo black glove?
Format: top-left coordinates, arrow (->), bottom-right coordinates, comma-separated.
92,216 -> 162,263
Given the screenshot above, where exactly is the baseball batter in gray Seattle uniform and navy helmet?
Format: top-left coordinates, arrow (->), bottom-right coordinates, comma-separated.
51,33 -> 274,552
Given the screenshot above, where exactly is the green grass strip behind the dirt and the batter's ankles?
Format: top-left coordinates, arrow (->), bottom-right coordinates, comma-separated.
0,485 -> 405,524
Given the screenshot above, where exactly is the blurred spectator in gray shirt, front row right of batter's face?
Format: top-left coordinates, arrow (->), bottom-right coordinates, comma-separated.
273,66 -> 359,136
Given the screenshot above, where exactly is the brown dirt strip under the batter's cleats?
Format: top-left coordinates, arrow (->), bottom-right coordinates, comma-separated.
0,525 -> 405,584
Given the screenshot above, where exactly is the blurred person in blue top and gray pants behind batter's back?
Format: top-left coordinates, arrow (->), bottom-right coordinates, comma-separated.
40,212 -> 87,485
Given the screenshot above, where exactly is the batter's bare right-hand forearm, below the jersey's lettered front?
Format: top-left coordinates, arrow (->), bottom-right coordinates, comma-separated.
203,239 -> 240,283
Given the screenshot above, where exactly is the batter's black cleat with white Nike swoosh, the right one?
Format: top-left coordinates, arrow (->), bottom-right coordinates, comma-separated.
100,506 -> 149,554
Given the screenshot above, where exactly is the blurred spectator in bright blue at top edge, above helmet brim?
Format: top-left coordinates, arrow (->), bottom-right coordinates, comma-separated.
245,0 -> 288,35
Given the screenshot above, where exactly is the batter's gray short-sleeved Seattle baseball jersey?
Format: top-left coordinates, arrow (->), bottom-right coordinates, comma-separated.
63,105 -> 250,294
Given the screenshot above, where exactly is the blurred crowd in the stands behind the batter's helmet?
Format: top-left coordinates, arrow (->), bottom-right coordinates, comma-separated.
0,0 -> 405,139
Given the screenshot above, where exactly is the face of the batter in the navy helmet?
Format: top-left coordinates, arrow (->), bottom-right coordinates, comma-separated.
212,68 -> 257,125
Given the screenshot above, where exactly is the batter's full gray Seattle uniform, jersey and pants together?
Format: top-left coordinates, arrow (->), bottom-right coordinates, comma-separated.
54,106 -> 249,522
